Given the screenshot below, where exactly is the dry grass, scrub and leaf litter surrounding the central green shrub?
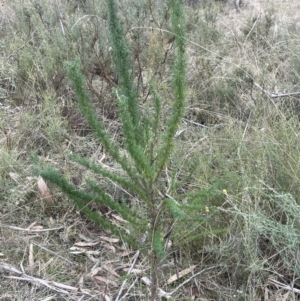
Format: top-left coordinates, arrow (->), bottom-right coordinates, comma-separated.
0,0 -> 300,301
